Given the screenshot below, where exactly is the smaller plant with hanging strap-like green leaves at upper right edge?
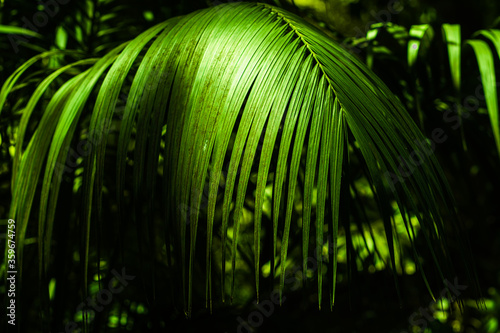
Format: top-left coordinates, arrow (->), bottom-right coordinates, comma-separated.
351,24 -> 500,156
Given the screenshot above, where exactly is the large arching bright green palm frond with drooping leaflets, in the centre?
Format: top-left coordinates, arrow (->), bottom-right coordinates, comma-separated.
0,3 -> 472,314
